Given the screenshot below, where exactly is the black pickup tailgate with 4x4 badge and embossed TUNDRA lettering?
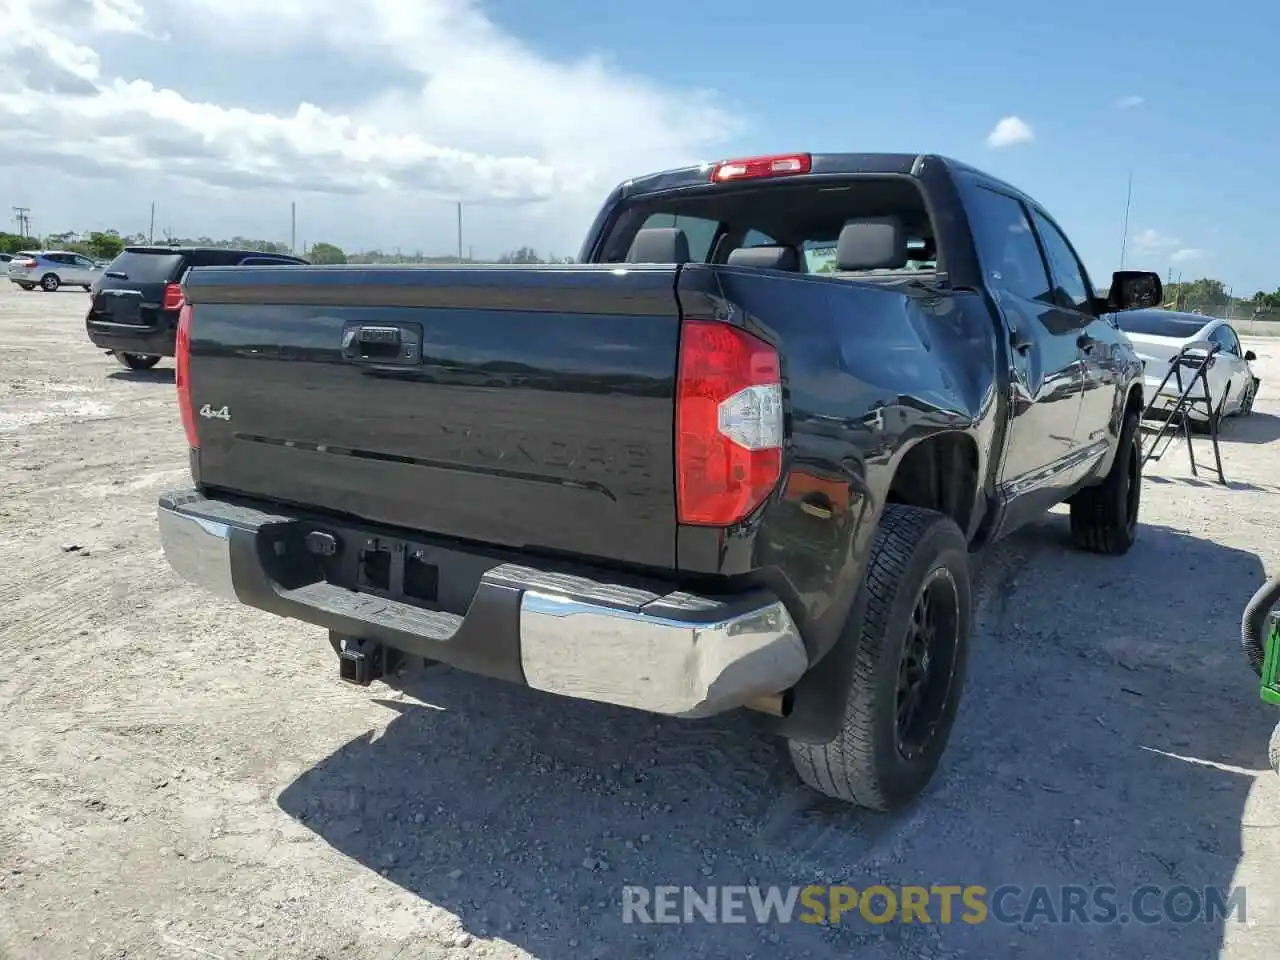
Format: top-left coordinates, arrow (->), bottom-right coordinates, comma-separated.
186,265 -> 680,568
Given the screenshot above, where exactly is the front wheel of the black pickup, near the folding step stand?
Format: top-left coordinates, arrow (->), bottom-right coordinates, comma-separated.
1070,413 -> 1142,556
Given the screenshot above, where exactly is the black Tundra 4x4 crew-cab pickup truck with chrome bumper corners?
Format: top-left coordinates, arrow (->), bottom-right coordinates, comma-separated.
159,154 -> 1162,809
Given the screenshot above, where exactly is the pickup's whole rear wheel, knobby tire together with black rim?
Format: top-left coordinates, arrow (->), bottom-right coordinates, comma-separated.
790,504 -> 973,812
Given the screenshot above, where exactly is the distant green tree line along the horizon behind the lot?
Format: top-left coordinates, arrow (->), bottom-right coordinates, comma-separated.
0,230 -> 1280,320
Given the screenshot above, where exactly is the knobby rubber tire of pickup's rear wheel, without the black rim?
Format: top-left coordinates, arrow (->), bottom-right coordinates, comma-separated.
788,504 -> 973,812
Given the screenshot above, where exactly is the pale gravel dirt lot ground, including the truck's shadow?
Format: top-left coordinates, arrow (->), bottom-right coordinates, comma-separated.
0,284 -> 1280,960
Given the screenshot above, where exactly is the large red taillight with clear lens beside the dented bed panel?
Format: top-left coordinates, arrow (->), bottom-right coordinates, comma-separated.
676,320 -> 785,526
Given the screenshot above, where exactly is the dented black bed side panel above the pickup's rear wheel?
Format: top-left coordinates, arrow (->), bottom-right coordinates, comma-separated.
747,280 -> 998,659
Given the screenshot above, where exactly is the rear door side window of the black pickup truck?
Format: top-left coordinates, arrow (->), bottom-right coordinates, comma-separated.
966,187 -> 1052,303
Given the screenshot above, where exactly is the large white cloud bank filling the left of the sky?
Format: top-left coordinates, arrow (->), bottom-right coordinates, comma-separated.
0,0 -> 735,255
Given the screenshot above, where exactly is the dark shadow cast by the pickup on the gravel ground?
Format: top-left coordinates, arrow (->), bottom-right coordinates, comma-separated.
278,527 -> 1276,960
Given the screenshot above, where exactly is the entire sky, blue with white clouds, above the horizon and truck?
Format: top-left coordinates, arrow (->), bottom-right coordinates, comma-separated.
0,0 -> 1280,292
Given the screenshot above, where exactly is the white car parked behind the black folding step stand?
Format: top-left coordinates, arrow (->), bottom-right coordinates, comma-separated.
1115,310 -> 1258,424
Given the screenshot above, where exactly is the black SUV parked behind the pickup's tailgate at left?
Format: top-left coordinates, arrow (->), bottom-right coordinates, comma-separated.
84,247 -> 307,370
